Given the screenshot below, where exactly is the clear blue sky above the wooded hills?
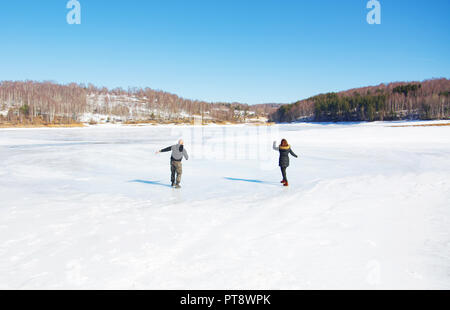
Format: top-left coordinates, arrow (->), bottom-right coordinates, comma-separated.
0,0 -> 450,104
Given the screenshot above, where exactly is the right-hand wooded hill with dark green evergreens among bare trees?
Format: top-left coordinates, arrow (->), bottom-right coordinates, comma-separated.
269,78 -> 450,123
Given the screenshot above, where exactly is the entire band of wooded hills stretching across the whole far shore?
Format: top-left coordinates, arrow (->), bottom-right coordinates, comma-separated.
0,78 -> 450,125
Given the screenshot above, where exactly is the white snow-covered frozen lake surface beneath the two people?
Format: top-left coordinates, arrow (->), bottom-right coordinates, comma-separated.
0,122 -> 450,289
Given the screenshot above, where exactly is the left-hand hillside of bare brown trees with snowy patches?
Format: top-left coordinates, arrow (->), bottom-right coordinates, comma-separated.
0,81 -> 279,124
